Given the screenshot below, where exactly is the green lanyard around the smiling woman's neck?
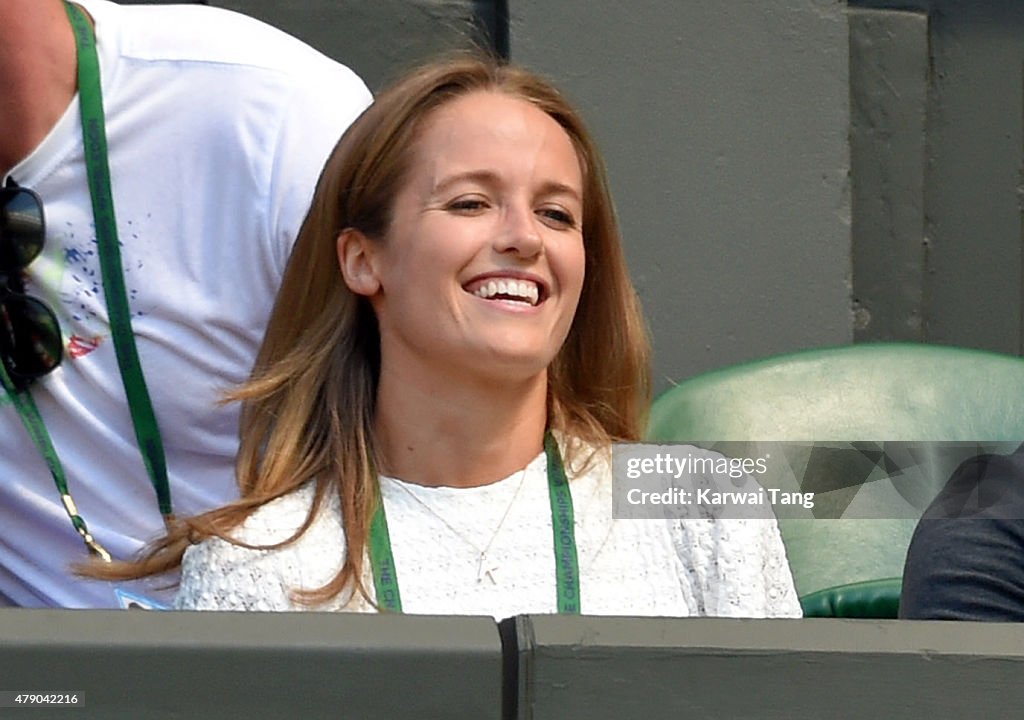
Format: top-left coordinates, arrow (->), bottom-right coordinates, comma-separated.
370,432 -> 580,615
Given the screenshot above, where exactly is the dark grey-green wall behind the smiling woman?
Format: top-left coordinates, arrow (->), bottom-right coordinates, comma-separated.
134,0 -> 1024,389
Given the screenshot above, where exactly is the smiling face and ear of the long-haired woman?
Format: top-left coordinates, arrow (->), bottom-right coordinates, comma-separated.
339,90 -> 585,411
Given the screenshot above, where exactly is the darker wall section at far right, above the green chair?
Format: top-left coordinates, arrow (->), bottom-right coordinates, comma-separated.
851,0 -> 1024,354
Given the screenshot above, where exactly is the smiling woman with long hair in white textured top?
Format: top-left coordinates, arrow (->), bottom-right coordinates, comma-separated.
90,58 -> 800,618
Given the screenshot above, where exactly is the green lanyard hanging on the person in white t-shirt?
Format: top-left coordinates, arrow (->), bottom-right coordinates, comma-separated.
0,2 -> 172,561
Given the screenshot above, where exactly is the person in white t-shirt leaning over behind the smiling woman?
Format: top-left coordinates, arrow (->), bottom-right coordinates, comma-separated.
0,0 -> 371,607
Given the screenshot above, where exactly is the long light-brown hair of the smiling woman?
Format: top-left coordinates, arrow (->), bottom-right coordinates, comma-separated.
89,56 -> 650,602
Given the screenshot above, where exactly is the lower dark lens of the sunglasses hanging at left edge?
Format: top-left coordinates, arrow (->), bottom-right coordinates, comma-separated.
0,295 -> 63,381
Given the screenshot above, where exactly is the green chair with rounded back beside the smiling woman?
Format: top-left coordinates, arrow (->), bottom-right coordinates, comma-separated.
648,343 -> 1024,618
